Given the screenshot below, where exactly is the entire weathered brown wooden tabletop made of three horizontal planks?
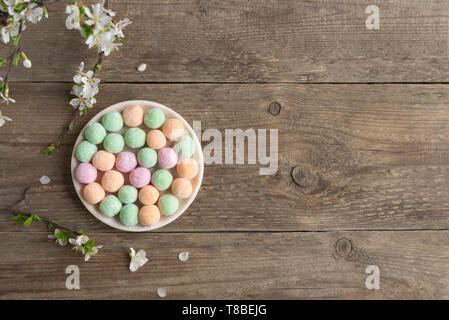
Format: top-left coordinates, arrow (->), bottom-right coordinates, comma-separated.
0,0 -> 449,299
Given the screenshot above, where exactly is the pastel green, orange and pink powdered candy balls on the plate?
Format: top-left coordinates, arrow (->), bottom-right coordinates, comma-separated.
75,105 -> 199,227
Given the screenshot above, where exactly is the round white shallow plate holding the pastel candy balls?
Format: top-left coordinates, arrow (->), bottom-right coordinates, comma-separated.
71,100 -> 204,232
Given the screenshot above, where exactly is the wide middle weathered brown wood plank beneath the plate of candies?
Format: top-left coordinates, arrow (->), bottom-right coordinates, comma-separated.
0,84 -> 449,231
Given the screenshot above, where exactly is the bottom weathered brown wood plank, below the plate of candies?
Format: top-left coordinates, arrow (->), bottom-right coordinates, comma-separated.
0,231 -> 449,299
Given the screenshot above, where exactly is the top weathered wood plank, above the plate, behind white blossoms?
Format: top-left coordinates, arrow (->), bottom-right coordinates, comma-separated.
0,0 -> 449,82
